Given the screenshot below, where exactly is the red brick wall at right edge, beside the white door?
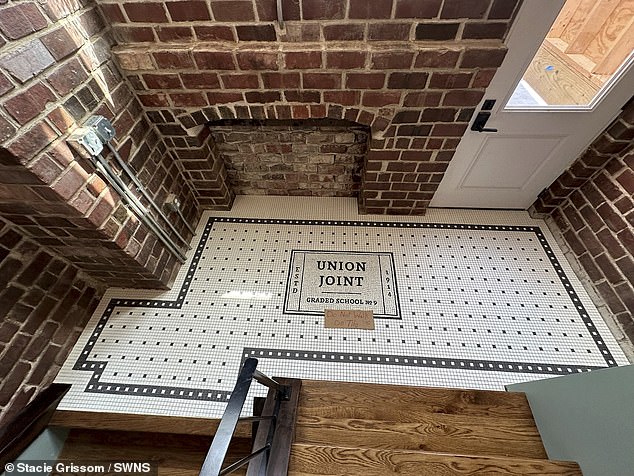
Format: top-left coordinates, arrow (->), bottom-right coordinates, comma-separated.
532,100 -> 634,342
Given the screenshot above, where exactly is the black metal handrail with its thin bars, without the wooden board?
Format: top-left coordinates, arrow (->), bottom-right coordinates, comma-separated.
200,358 -> 291,476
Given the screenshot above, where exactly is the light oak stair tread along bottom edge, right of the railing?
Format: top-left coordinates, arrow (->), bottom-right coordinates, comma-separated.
288,444 -> 581,476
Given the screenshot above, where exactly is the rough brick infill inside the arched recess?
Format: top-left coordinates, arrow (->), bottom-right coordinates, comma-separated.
209,120 -> 368,197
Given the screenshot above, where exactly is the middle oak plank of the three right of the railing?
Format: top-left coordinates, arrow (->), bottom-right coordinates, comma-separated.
295,414 -> 547,459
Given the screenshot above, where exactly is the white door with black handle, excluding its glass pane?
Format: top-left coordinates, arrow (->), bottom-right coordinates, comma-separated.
430,0 -> 634,209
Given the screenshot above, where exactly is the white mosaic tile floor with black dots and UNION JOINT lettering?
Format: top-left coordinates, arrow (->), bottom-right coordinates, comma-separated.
56,197 -> 628,417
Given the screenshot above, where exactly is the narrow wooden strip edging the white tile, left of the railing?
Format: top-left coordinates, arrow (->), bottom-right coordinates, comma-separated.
49,410 -> 251,438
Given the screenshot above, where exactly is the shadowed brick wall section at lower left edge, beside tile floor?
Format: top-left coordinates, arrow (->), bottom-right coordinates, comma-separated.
0,219 -> 103,425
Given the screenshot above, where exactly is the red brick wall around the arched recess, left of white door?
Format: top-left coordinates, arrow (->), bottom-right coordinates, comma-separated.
100,0 -> 519,214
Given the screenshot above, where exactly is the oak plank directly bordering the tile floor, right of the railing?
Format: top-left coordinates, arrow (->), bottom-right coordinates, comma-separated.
299,380 -> 533,421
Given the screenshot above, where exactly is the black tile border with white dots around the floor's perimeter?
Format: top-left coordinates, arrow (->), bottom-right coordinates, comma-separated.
73,217 -> 617,402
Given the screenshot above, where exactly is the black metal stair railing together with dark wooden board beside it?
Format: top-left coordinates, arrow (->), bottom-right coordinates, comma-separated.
200,358 -> 301,476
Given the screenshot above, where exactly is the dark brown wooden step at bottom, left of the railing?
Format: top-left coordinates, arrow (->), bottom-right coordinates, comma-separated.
59,429 -> 251,476
